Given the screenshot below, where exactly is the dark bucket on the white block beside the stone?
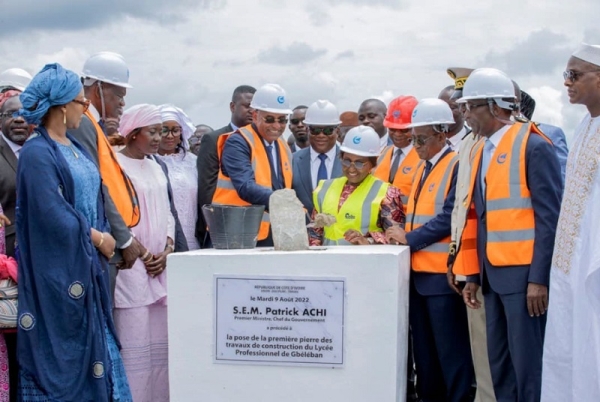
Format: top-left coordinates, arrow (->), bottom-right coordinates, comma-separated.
202,204 -> 265,250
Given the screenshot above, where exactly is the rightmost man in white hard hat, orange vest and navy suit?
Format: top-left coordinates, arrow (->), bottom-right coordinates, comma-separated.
458,68 -> 562,402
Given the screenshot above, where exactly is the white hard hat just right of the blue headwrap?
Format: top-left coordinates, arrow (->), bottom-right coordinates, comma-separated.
82,52 -> 131,88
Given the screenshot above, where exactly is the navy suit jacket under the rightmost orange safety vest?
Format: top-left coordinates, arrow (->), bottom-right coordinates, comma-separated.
467,134 -> 562,294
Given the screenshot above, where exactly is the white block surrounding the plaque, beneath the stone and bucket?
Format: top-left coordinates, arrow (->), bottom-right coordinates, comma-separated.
168,246 -> 410,402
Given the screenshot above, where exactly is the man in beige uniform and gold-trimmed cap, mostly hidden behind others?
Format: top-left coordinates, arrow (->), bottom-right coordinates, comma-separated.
441,67 -> 496,402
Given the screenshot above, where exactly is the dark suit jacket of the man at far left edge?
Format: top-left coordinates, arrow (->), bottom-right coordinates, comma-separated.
0,136 -> 18,257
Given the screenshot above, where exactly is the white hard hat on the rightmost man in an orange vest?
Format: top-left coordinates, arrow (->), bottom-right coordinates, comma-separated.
456,68 -> 516,109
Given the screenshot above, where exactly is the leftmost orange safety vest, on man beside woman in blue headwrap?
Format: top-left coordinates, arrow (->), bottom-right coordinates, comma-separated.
85,109 -> 140,228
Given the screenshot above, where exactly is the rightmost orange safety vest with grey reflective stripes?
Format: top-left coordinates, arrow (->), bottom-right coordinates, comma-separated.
471,123 -> 551,267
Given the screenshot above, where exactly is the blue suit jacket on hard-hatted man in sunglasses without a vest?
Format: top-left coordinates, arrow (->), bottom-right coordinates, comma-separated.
292,145 -> 342,215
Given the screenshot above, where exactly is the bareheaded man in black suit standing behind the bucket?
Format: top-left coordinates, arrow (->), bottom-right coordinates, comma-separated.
196,85 -> 256,248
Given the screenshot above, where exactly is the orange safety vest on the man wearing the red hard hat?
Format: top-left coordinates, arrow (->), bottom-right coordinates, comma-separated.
373,145 -> 421,213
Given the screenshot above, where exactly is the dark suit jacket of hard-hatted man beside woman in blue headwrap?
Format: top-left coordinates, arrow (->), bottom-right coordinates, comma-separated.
69,115 -> 131,250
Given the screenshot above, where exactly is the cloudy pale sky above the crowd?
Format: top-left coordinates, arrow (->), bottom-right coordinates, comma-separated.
0,0 -> 600,139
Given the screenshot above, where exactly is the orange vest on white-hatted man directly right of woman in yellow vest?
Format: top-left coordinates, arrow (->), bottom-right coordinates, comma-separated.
406,151 -> 458,274
